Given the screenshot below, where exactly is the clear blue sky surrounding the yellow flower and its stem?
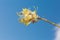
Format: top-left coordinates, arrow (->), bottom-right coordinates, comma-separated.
0,0 -> 60,40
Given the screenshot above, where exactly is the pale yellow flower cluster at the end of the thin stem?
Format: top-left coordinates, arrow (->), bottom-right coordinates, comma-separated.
19,8 -> 38,25
